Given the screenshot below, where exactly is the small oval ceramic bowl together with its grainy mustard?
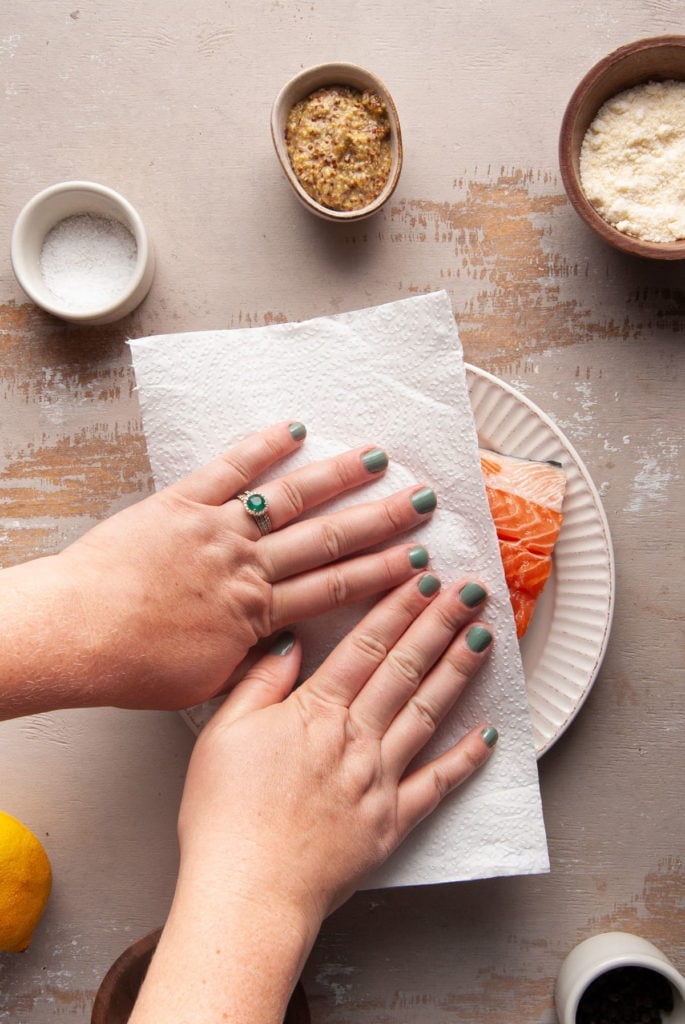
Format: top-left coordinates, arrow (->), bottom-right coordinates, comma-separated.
271,62 -> 402,222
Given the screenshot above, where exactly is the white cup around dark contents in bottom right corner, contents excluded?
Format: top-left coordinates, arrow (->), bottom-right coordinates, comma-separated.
554,932 -> 685,1024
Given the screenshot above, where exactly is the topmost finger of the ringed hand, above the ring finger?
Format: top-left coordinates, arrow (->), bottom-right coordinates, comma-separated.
172,420 -> 307,505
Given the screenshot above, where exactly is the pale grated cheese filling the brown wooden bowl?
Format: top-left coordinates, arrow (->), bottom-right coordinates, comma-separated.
580,80 -> 685,242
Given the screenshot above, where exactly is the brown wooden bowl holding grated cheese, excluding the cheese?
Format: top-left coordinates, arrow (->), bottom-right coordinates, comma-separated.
559,36 -> 685,260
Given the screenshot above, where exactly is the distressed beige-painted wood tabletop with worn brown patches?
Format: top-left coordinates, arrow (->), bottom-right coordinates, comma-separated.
0,0 -> 685,1024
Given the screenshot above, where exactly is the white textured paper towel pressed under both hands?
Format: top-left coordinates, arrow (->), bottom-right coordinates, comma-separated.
130,292 -> 549,888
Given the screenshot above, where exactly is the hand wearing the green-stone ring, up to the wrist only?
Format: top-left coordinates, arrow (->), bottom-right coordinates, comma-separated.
48,423 -> 435,709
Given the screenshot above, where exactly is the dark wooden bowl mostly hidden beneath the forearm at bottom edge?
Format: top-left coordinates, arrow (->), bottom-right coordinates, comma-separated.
90,928 -> 310,1024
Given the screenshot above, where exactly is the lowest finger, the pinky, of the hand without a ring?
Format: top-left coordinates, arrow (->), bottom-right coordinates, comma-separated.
397,725 -> 498,839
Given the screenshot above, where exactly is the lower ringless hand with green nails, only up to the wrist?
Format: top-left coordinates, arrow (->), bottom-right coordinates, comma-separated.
179,574 -> 497,941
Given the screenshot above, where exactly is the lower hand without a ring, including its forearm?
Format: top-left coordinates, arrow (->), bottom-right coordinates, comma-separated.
125,573 -> 497,1024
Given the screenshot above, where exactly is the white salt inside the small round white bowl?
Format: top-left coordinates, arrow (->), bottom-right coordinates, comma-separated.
40,213 -> 138,311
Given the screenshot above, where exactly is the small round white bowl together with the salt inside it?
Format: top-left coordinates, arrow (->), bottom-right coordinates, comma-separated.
10,181 -> 155,325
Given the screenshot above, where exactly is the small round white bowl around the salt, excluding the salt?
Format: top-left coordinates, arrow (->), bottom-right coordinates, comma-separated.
10,181 -> 155,325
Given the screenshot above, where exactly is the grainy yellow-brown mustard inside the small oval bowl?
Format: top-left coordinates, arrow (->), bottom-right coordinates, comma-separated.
286,85 -> 391,211
